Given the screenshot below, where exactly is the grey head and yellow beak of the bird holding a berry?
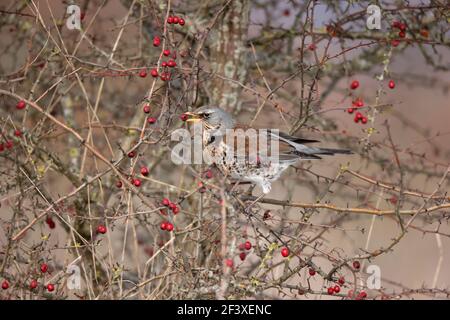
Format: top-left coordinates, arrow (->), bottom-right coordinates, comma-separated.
186,106 -> 235,134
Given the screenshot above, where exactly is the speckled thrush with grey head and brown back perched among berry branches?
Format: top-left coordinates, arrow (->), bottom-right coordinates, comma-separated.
184,105 -> 353,194
